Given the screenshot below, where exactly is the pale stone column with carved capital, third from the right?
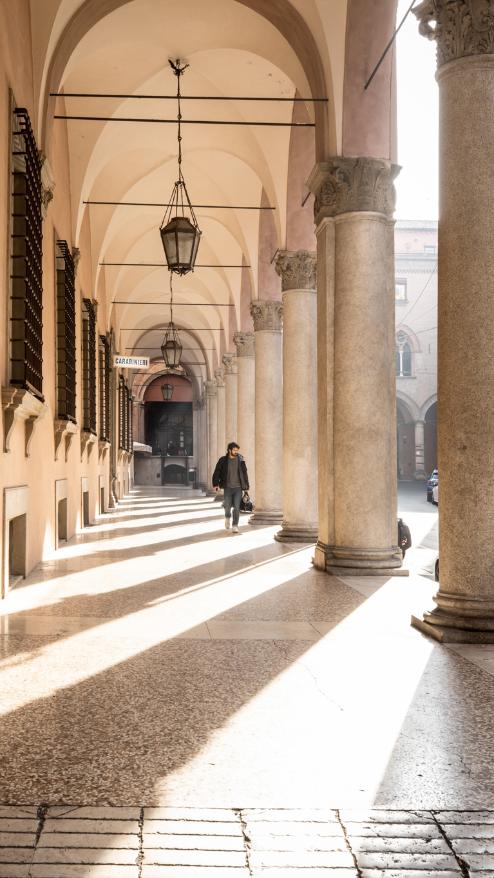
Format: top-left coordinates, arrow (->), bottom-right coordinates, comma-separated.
275,250 -> 317,543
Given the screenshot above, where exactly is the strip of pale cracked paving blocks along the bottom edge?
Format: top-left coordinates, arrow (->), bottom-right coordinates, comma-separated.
0,805 -> 494,878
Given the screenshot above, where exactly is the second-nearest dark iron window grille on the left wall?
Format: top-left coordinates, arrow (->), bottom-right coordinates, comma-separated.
56,241 -> 76,421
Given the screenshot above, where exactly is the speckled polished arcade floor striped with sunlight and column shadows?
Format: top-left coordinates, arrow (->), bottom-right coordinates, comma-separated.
0,489 -> 494,820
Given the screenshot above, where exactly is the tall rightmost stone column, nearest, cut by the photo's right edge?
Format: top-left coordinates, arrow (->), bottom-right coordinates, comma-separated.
412,0 -> 494,643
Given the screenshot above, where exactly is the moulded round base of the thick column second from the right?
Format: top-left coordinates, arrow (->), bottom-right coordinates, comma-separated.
313,541 -> 409,576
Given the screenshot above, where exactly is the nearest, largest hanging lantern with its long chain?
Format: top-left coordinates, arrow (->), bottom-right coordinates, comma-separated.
160,59 -> 201,275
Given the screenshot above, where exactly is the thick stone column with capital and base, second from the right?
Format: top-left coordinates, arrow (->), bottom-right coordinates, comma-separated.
309,156 -> 402,575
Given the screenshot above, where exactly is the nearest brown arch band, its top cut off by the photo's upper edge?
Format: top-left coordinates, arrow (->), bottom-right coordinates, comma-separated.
40,0 -> 337,160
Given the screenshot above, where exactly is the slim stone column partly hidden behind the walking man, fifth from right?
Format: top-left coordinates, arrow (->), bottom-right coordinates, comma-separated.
233,332 -> 256,502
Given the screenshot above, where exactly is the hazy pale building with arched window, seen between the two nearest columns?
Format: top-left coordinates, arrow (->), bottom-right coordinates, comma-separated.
395,220 -> 437,480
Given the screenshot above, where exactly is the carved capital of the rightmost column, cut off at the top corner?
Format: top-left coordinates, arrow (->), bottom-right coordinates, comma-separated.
413,0 -> 494,67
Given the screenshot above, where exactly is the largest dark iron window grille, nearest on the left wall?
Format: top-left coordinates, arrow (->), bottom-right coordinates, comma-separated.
10,108 -> 43,399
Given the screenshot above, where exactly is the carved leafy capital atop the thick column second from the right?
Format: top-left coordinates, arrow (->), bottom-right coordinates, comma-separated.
307,156 -> 400,225
